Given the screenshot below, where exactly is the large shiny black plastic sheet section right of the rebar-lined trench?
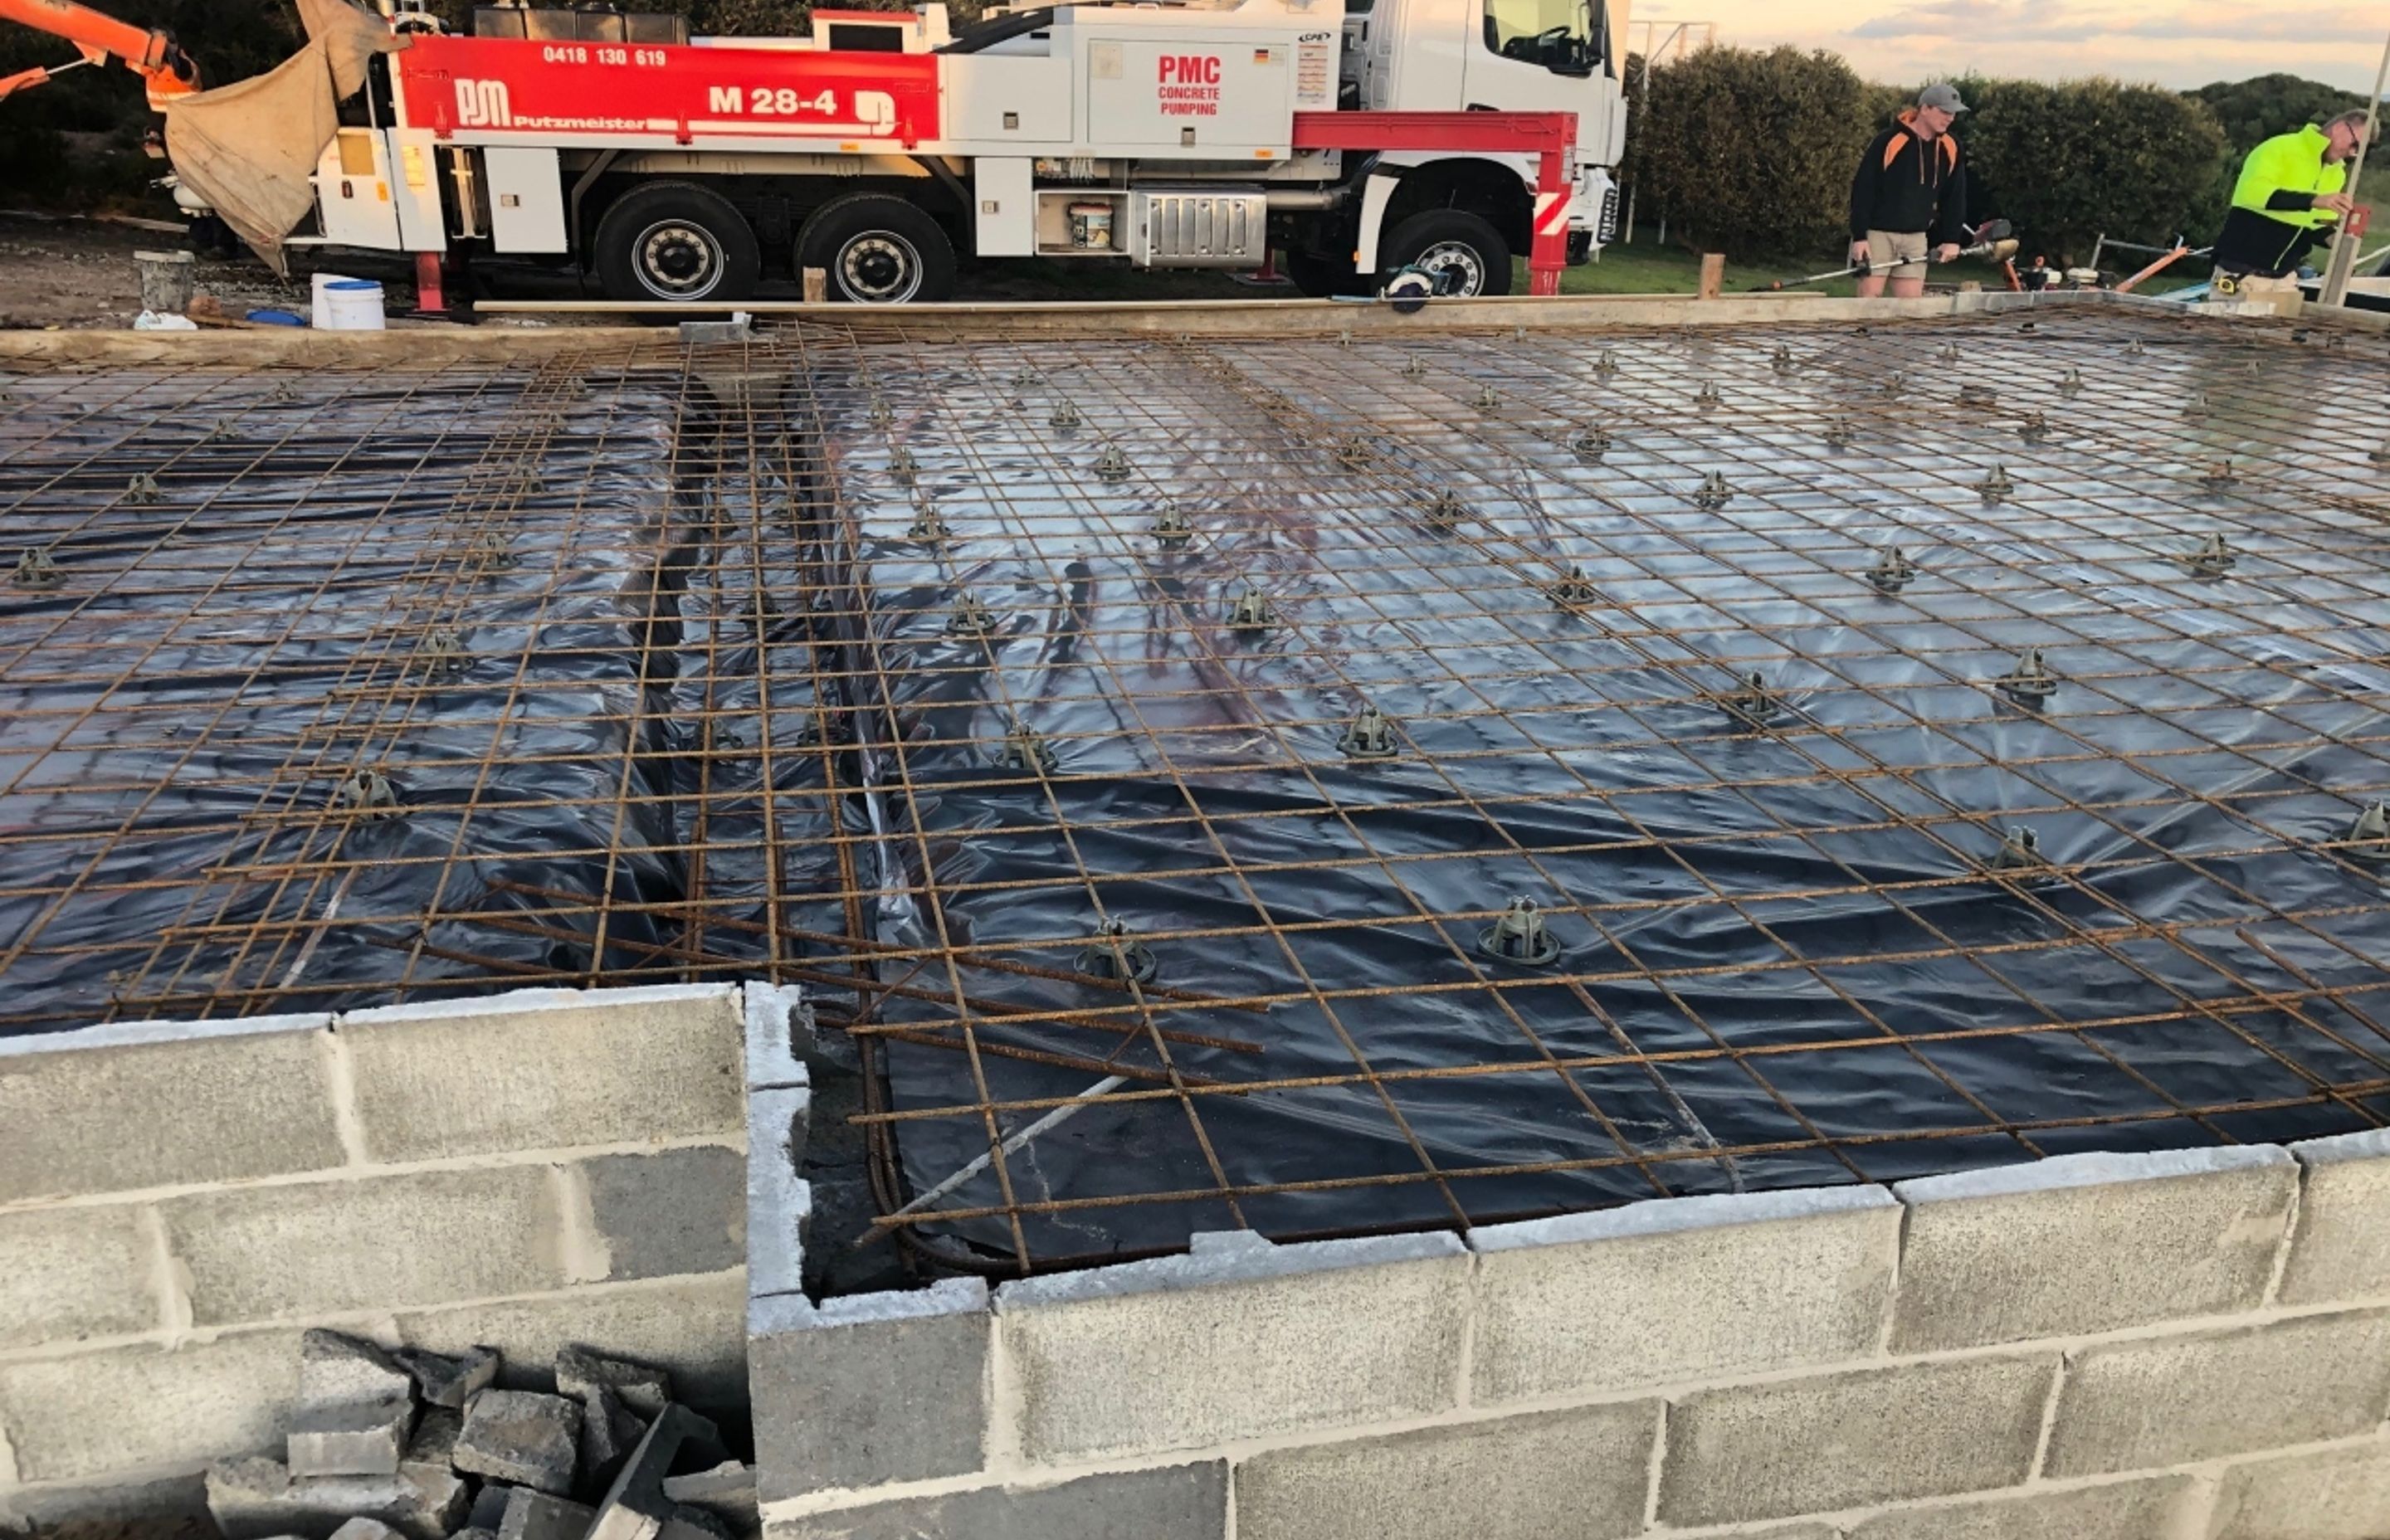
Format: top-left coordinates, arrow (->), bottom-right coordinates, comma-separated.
825,318 -> 2390,1260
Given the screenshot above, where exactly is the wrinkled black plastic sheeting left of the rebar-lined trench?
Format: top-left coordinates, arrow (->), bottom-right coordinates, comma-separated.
0,371 -> 806,1031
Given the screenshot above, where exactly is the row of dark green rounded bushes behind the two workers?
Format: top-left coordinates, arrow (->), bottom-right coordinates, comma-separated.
1625,48 -> 2363,268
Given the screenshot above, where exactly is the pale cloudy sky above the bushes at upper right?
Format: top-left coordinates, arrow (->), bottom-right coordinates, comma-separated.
1627,0 -> 2390,91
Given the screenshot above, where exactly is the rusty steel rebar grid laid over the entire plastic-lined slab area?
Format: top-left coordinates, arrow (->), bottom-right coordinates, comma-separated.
13,297 -> 2390,1270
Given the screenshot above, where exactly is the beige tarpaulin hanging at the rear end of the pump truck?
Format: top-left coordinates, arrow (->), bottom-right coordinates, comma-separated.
165,0 -> 407,273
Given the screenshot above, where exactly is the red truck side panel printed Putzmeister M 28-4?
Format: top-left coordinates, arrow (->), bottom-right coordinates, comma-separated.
397,36 -> 939,144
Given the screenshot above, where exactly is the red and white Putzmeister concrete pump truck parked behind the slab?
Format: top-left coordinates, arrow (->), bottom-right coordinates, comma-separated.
275,0 -> 1625,304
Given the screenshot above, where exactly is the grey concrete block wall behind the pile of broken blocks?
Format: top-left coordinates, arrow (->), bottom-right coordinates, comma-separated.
0,987 -> 748,1526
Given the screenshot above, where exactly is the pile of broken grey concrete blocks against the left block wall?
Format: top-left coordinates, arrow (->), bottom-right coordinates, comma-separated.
206,1332 -> 731,1540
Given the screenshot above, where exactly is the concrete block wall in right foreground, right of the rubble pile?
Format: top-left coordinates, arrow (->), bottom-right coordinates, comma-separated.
748,1047 -> 2390,1540
